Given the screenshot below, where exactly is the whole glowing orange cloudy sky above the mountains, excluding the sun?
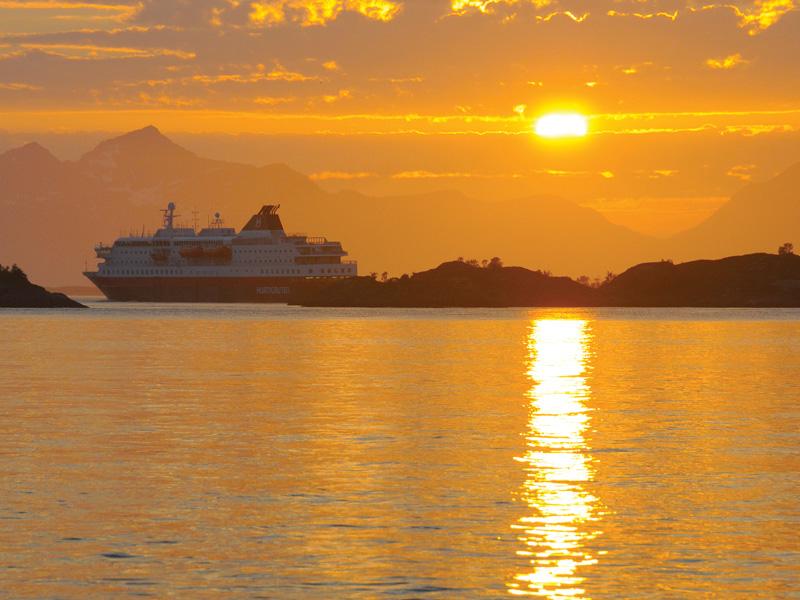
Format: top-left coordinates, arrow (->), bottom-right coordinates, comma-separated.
0,0 -> 800,234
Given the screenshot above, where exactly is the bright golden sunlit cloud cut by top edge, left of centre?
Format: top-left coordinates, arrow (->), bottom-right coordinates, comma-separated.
249,0 -> 402,27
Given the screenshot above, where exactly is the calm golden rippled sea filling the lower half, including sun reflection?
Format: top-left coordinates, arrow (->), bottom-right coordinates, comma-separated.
0,303 -> 800,599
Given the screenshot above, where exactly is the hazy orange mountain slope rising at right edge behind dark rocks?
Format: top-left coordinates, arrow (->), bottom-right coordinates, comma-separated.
671,163 -> 800,259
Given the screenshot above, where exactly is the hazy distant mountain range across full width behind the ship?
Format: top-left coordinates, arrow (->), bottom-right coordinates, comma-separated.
0,126 -> 800,285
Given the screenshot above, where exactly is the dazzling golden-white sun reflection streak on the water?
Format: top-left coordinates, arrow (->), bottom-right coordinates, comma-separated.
508,319 -> 602,599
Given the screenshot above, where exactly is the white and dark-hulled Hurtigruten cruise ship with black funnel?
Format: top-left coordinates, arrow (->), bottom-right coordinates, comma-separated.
84,202 -> 358,302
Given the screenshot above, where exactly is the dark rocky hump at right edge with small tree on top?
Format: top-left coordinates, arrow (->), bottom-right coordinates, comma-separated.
599,253 -> 800,307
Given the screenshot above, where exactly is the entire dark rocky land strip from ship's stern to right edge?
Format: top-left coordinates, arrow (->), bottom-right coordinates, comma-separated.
292,253 -> 800,308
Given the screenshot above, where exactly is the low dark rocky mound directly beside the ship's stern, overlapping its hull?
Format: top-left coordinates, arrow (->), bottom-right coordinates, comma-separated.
293,261 -> 596,308
